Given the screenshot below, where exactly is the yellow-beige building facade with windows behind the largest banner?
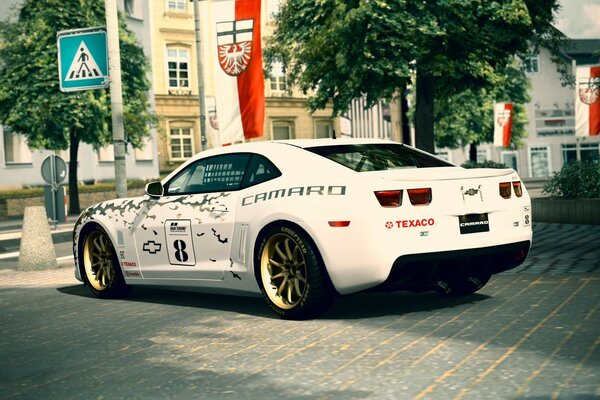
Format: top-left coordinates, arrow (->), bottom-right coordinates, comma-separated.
151,0 -> 340,175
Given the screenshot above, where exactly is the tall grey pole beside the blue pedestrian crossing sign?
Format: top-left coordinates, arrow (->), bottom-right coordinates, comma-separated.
104,0 -> 127,198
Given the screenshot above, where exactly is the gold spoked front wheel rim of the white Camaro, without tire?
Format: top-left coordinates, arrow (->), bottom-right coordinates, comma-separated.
83,231 -> 115,291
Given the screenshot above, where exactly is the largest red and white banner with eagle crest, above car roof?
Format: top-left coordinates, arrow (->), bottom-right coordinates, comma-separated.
212,0 -> 265,145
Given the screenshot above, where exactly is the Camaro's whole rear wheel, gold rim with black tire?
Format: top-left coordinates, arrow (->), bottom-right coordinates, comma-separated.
254,223 -> 335,320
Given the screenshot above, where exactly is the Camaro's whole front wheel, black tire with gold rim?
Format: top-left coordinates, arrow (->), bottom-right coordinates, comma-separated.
78,225 -> 131,299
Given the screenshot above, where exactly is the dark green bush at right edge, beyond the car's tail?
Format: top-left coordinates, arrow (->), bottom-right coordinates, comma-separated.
542,162 -> 600,199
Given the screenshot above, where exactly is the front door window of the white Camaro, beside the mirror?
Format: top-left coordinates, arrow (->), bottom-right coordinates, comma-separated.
165,154 -> 250,195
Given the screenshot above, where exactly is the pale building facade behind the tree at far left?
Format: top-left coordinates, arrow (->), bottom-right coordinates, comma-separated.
0,0 -> 159,189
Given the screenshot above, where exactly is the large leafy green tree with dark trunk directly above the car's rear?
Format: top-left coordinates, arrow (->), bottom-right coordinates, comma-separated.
265,0 -> 564,151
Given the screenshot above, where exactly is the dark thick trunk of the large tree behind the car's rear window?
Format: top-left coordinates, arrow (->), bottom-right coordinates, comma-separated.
415,70 -> 435,153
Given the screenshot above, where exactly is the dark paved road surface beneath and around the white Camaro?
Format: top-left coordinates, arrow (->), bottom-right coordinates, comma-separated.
0,224 -> 600,400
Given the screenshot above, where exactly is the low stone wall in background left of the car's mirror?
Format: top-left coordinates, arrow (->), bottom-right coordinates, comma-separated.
0,189 -> 144,221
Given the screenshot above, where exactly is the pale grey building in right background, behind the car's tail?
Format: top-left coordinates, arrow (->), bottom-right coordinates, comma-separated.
446,39 -> 600,180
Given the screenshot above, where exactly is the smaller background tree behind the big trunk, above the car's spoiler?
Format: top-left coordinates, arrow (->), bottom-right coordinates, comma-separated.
434,60 -> 530,157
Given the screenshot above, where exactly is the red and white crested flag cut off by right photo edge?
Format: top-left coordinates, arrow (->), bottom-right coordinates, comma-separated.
575,65 -> 600,136
